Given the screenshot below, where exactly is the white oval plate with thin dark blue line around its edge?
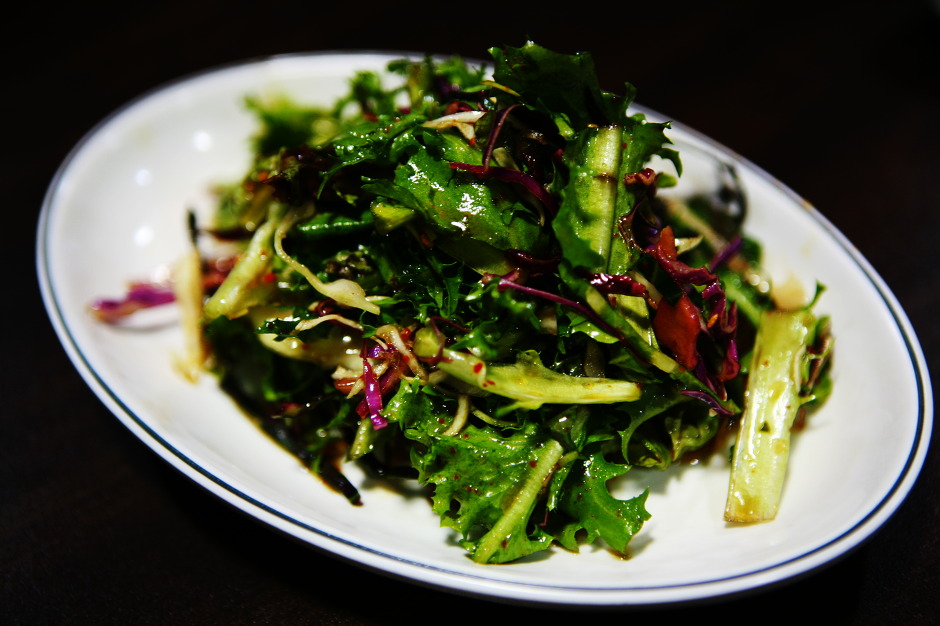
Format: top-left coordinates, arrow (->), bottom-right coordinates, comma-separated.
37,53 -> 933,605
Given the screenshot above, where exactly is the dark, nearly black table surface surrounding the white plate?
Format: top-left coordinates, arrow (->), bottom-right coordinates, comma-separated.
7,0 -> 940,624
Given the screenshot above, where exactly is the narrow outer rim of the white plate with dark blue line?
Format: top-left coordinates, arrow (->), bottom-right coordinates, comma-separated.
35,49 -> 933,606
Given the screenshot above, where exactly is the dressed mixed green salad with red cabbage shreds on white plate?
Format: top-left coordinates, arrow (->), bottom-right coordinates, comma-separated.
92,42 -> 832,563
